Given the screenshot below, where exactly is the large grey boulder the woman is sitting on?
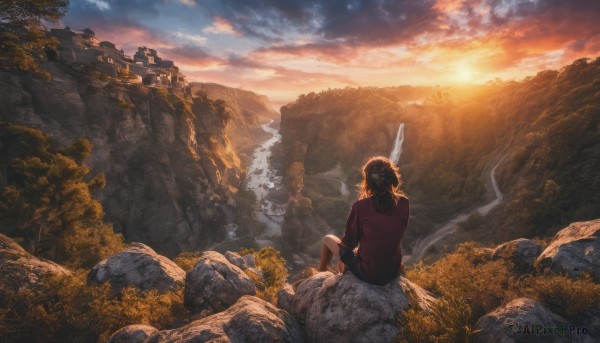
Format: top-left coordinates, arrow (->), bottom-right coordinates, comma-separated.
278,272 -> 434,343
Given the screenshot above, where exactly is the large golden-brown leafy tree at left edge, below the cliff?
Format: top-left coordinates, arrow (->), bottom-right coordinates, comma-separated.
0,123 -> 123,267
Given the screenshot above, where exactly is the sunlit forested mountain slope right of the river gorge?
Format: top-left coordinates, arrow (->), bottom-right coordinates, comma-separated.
281,59 -> 600,254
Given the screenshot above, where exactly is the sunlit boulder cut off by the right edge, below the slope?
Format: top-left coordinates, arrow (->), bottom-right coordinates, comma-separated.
537,219 -> 600,280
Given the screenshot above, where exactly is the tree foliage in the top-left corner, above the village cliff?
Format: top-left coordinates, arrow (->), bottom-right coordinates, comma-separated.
0,0 -> 69,78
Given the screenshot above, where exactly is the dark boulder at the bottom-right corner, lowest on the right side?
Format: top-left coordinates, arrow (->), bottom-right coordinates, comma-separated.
475,298 -> 595,343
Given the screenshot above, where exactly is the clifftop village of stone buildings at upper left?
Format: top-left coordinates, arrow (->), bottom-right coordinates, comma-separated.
50,26 -> 187,90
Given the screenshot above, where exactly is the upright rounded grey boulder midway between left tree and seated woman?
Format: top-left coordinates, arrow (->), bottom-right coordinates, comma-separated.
184,251 -> 256,313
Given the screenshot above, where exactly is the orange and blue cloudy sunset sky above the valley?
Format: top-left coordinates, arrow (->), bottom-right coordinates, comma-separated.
61,0 -> 600,109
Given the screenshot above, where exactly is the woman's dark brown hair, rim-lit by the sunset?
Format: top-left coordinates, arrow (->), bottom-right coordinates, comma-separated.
358,156 -> 405,213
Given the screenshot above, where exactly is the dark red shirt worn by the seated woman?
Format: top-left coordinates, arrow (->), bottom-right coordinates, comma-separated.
339,197 -> 409,285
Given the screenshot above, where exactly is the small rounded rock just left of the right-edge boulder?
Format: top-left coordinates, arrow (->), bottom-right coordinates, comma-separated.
492,238 -> 544,272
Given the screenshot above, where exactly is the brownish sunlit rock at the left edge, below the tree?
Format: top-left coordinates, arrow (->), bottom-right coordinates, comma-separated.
0,234 -> 71,298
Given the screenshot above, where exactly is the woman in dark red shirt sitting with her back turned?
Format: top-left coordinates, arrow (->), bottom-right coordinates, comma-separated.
319,157 -> 409,285
